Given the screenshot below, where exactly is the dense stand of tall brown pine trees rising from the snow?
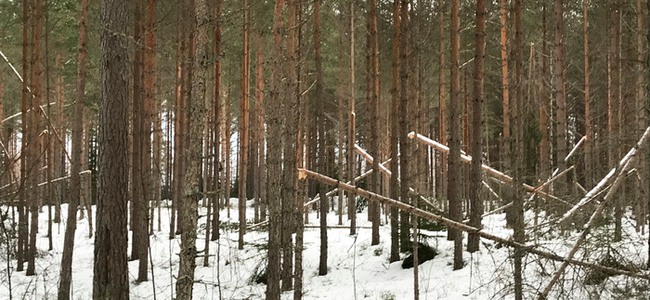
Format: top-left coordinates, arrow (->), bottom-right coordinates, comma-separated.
0,0 -> 650,299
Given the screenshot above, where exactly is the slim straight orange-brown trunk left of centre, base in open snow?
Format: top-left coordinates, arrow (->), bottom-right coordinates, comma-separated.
237,0 -> 251,250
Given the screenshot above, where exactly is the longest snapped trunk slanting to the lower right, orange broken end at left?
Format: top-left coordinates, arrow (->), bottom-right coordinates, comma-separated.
298,169 -> 650,280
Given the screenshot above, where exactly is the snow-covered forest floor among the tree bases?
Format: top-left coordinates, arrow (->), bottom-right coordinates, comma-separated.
0,199 -> 650,300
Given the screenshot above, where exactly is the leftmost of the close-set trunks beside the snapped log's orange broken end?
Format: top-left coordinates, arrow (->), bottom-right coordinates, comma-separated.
265,0 -> 285,300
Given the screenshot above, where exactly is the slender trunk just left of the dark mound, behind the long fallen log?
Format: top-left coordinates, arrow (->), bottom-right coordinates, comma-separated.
389,0 -> 401,262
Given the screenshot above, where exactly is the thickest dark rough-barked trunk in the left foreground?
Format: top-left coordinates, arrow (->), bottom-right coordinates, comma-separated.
93,0 -> 129,300
